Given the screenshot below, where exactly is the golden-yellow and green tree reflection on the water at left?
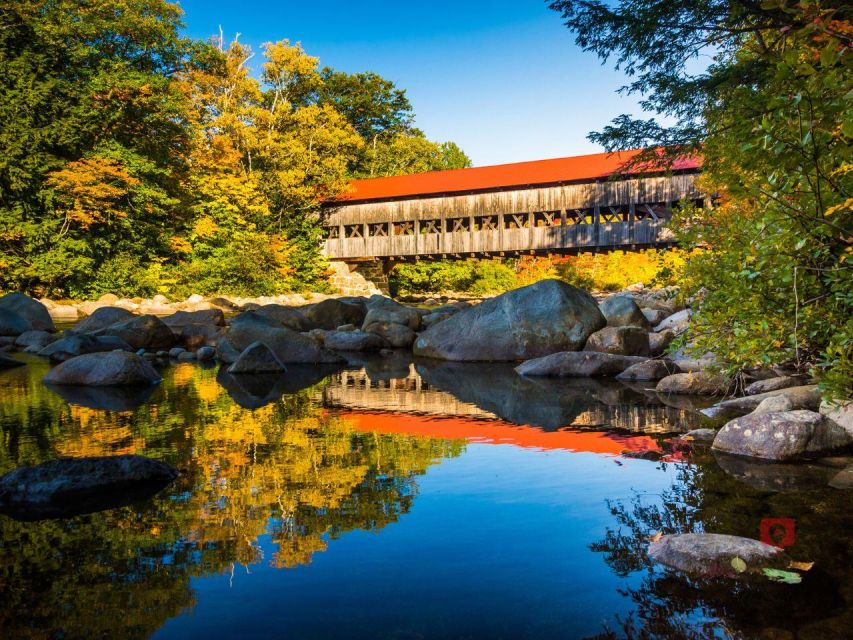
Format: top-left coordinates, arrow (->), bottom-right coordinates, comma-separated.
0,362 -> 464,638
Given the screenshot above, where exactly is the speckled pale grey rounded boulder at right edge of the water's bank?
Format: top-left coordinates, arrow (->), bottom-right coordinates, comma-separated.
713,410 -> 853,461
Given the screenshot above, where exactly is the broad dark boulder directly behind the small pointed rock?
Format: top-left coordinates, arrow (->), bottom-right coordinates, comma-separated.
217,311 -> 344,364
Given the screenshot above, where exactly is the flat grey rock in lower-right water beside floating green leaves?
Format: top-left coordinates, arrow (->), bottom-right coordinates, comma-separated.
649,533 -> 791,578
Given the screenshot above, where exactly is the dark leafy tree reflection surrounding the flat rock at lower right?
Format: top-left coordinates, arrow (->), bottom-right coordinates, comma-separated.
590,452 -> 853,640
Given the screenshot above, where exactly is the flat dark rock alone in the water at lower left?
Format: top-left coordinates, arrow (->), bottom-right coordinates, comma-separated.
0,455 -> 178,520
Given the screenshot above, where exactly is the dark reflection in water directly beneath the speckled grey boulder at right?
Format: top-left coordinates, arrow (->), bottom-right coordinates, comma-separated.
713,451 -> 835,493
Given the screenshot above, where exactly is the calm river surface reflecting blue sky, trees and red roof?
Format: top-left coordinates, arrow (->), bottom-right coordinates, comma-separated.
0,356 -> 853,639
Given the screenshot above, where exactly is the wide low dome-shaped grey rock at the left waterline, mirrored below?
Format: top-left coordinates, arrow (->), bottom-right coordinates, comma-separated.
44,351 -> 161,387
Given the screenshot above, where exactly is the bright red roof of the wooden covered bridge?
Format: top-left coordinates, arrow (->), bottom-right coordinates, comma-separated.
336,150 -> 701,202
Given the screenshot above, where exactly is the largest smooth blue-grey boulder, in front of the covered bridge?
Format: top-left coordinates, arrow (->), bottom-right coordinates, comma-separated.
414,280 -> 606,361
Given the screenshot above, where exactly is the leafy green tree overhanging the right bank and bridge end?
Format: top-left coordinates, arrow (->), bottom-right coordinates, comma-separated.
551,0 -> 853,396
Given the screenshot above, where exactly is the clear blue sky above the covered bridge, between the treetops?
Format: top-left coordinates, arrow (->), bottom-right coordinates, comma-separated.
180,0 -> 639,166
